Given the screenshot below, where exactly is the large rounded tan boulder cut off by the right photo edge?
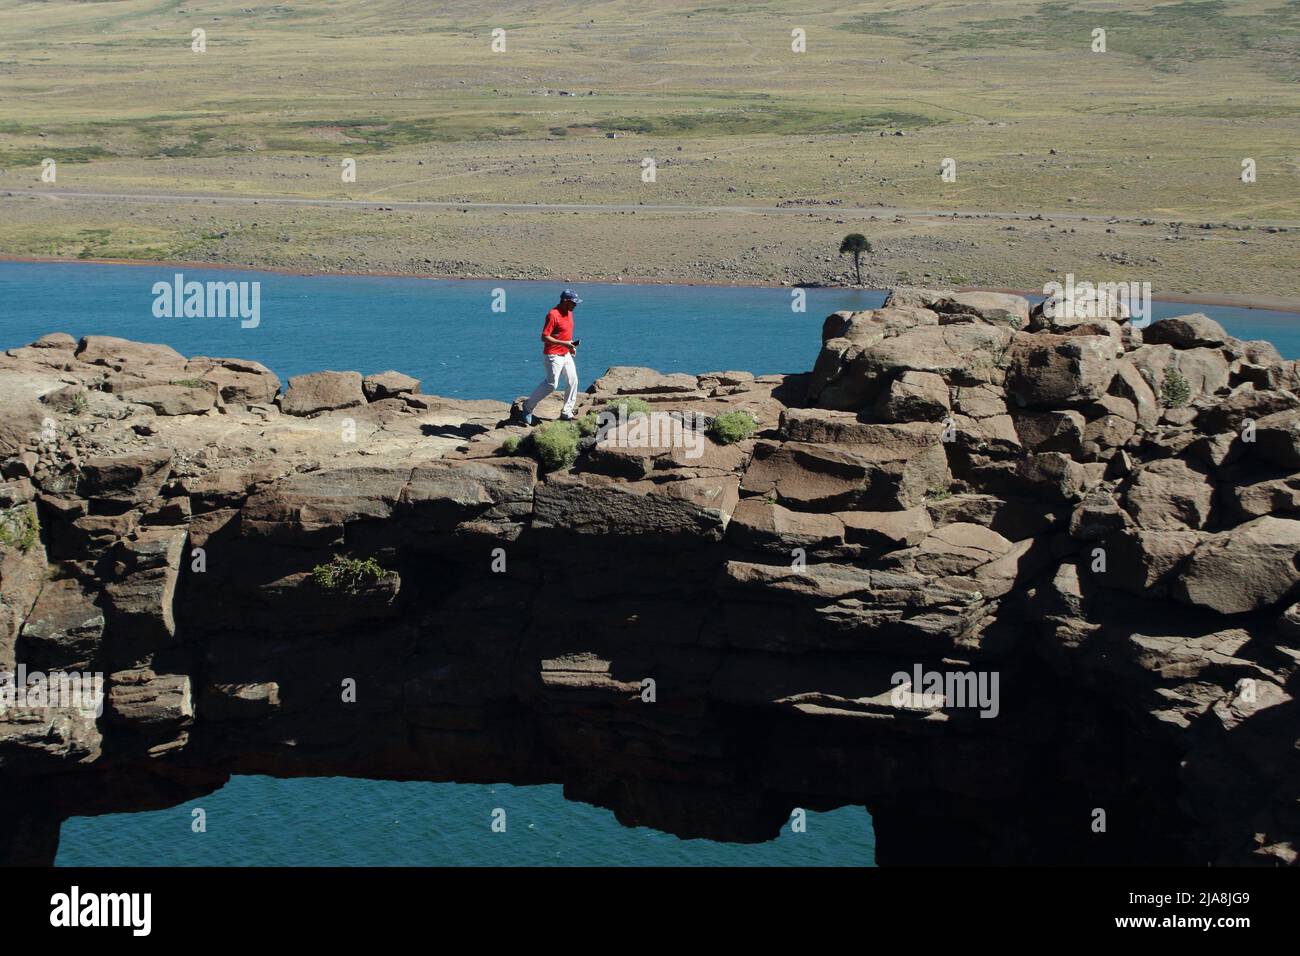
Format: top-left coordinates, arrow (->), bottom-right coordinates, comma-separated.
1171,515 -> 1300,614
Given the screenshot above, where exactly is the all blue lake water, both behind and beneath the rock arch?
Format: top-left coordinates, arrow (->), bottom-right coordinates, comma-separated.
0,263 -> 1300,866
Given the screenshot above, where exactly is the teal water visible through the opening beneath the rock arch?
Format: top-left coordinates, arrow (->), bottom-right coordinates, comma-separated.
57,777 -> 875,866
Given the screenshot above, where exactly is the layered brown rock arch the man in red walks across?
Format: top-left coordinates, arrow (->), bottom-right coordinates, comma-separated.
0,303 -> 1300,865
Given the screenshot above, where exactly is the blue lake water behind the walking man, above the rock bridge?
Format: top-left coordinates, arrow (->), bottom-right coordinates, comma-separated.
0,263 -> 1300,401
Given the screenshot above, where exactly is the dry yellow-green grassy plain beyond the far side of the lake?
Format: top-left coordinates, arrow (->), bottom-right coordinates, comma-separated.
0,0 -> 1300,297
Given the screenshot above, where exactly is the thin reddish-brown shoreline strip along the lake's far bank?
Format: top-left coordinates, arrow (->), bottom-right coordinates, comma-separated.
0,252 -> 1300,315
